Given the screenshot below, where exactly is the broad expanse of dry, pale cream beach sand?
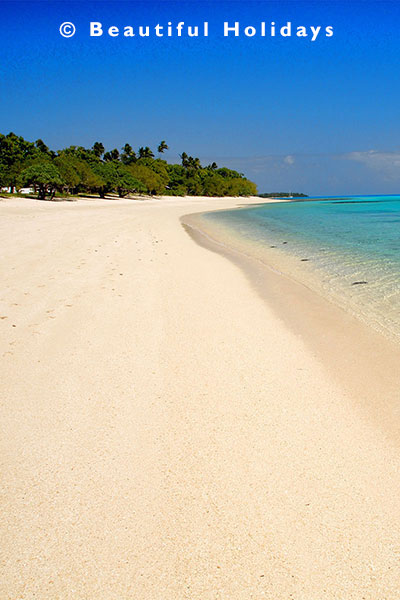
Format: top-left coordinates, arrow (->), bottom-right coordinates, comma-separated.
0,199 -> 400,600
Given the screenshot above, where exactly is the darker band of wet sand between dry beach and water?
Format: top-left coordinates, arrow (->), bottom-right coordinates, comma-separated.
181,211 -> 400,445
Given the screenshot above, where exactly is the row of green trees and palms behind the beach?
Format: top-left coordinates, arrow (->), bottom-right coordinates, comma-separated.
0,133 -> 257,199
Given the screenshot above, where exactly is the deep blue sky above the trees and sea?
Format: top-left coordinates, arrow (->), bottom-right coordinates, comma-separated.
0,0 -> 400,195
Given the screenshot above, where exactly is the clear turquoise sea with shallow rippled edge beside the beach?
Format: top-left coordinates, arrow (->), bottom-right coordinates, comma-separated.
204,196 -> 400,336
